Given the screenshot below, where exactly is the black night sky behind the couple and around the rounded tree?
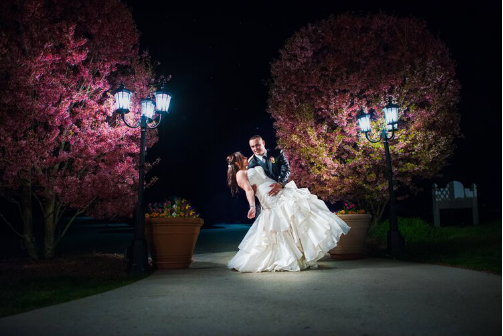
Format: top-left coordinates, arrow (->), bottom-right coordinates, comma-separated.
126,0 -> 502,224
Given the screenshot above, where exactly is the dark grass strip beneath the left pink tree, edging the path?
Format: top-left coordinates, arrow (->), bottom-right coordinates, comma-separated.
0,253 -> 149,317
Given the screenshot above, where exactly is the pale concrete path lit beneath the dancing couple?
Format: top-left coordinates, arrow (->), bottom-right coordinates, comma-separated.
0,252 -> 502,336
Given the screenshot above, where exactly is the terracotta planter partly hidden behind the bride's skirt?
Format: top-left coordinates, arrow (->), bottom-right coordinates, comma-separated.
329,214 -> 372,260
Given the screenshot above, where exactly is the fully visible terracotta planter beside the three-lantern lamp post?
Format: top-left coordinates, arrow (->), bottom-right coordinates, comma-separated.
145,217 -> 204,269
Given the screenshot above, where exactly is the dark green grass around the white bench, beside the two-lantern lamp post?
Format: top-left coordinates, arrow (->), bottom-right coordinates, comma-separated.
369,218 -> 502,275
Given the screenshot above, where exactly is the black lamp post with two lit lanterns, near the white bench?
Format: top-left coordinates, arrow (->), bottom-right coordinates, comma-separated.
357,99 -> 405,256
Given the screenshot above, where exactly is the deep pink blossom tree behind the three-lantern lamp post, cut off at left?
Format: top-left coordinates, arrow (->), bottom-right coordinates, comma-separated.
0,0 -> 157,259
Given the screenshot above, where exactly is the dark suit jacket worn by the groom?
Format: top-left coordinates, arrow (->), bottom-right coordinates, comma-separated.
248,149 -> 290,187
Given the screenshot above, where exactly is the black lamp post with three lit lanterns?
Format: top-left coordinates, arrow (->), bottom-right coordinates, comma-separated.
114,83 -> 171,273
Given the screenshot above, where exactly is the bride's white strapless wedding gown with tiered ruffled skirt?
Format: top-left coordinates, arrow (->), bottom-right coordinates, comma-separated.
227,166 -> 350,272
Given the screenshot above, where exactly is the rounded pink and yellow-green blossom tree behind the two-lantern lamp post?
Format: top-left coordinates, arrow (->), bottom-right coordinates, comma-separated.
268,13 -> 460,223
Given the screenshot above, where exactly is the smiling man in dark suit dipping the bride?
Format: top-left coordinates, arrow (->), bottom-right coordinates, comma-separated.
248,135 -> 290,196
